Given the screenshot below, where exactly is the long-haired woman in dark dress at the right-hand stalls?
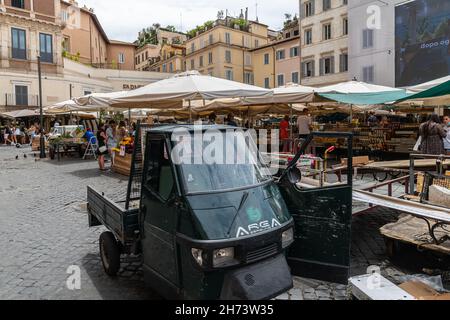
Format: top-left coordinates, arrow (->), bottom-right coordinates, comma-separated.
419,114 -> 447,155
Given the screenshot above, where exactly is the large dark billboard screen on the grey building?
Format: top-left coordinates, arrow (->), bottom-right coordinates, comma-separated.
395,0 -> 450,87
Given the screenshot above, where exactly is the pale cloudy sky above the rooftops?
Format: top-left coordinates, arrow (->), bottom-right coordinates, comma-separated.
78,0 -> 299,42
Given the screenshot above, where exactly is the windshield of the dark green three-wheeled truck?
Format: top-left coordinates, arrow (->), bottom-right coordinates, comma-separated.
172,130 -> 271,193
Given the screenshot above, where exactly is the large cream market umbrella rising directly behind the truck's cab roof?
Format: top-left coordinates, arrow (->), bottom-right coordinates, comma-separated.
111,71 -> 272,108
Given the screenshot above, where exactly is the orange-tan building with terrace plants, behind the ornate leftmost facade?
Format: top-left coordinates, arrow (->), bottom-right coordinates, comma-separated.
59,0 -> 136,70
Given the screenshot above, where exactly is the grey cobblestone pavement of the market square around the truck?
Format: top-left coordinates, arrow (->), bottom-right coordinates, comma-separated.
0,146 -> 442,300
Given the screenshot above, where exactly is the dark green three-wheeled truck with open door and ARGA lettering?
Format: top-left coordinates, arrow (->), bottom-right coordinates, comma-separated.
88,125 -> 352,300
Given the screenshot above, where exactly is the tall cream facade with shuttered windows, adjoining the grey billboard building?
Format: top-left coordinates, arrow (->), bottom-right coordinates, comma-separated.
300,0 -> 350,86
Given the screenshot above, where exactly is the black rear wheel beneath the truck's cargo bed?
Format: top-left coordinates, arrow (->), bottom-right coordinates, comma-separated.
99,231 -> 120,277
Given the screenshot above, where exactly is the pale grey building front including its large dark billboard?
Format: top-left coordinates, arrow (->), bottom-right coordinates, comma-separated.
348,0 -> 450,87
